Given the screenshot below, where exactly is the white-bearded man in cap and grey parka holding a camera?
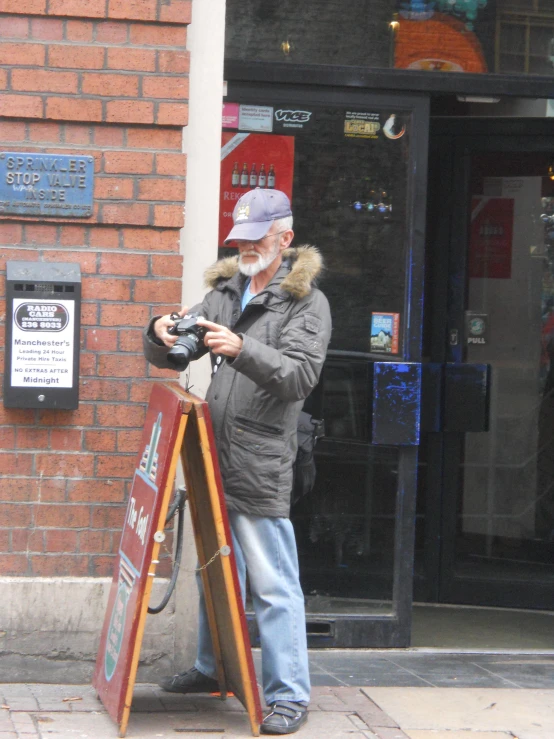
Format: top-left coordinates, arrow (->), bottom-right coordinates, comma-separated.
144,188 -> 331,734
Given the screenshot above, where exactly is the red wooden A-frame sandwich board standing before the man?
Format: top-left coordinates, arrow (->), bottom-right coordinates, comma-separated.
93,383 -> 262,737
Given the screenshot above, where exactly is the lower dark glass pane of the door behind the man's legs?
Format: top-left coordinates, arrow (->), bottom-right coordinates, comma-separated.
292,353 -> 398,613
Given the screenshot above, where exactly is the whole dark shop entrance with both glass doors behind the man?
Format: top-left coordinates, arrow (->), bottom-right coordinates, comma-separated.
222,64 -> 554,647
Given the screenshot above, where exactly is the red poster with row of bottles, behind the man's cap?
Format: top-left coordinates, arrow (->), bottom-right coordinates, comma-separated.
219,132 -> 294,246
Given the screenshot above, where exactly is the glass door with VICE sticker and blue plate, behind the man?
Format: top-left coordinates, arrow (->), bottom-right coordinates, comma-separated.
221,79 -> 428,647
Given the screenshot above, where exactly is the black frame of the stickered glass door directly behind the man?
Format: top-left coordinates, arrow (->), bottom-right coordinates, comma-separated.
221,78 -> 429,647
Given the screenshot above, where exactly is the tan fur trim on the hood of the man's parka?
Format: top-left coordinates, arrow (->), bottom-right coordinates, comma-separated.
204,245 -> 323,300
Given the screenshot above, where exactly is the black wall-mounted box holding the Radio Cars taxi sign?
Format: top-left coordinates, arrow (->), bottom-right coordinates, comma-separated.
4,262 -> 81,409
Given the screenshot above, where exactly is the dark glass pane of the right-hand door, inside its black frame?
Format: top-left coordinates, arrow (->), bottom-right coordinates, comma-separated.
456,154 -> 554,596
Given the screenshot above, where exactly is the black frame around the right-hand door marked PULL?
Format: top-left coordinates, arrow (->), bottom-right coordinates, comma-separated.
425,118 -> 554,609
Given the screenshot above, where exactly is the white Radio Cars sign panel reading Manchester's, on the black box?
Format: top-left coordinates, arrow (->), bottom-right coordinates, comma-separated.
11,298 -> 75,387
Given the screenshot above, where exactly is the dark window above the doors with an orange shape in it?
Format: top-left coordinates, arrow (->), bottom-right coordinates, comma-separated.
225,0 -> 554,75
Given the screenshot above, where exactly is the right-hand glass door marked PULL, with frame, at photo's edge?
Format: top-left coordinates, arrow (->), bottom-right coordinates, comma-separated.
422,129 -> 554,610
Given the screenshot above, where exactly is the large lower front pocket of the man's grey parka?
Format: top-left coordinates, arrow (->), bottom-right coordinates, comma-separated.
226,420 -> 285,500
